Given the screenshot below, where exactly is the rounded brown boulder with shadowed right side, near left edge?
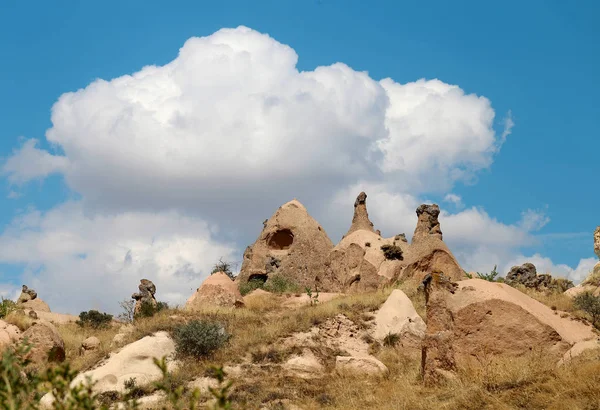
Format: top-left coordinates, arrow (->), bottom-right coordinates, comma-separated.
22,321 -> 65,364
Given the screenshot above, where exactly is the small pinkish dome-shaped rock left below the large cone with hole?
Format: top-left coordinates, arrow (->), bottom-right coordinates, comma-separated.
184,272 -> 244,311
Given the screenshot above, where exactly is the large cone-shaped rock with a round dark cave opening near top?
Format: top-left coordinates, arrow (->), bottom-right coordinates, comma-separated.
237,200 -> 336,291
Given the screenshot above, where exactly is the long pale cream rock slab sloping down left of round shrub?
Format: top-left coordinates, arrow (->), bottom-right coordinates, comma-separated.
40,332 -> 176,408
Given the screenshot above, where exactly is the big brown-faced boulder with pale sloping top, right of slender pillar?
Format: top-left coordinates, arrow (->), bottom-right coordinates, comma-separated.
448,279 -> 597,360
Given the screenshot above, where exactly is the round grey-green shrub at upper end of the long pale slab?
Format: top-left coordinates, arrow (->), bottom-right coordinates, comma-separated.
174,320 -> 230,358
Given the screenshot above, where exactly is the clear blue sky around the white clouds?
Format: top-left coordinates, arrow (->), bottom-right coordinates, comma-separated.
0,0 -> 600,309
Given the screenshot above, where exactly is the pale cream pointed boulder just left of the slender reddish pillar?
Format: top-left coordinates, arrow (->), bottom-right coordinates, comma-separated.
373,289 -> 426,347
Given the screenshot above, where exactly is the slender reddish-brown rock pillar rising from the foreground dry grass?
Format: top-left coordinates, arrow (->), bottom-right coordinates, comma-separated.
421,272 -> 458,386
